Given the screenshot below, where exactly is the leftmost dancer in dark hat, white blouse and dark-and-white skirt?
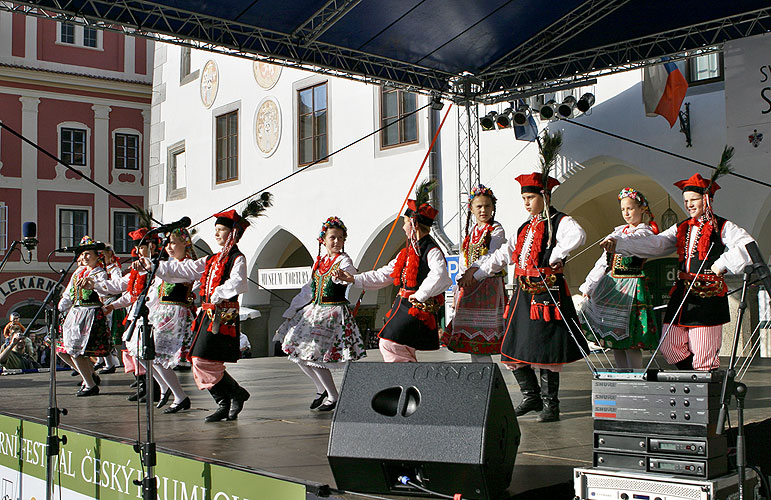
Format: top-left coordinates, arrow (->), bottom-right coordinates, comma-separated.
57,236 -> 112,397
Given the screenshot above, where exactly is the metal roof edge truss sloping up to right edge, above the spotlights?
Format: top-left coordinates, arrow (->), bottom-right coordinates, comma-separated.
479,7 -> 771,93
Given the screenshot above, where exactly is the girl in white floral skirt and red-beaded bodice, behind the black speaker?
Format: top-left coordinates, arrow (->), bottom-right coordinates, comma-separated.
274,217 -> 367,411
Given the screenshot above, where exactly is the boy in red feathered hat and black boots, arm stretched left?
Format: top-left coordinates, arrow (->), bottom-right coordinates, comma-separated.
152,192 -> 272,422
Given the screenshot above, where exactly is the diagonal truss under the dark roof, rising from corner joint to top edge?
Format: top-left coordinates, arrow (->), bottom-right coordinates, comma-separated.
480,0 -> 630,74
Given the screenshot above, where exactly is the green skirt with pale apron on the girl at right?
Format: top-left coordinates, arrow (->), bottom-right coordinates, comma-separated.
580,274 -> 659,350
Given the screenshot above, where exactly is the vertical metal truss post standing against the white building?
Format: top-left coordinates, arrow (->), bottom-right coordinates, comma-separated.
458,100 -> 479,246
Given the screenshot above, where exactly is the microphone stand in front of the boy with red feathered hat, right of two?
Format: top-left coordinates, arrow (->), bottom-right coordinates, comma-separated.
126,234 -> 169,500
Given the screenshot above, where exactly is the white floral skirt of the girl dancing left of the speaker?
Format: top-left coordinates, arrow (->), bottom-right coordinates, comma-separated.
274,304 -> 367,370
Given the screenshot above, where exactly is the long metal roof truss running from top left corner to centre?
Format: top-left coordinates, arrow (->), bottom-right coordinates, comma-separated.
0,0 -> 455,92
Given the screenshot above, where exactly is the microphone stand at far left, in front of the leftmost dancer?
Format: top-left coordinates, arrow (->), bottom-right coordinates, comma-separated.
38,253 -> 79,500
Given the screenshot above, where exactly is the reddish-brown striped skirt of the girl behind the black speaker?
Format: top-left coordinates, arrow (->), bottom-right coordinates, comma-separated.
440,276 -> 506,354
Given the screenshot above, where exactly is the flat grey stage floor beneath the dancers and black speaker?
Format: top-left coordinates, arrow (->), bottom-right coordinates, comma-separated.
0,350 -> 771,500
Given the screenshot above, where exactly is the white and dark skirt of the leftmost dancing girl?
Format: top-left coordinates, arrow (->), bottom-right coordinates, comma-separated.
57,306 -> 112,356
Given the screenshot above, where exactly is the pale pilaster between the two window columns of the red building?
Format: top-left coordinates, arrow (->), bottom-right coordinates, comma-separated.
91,104 -> 112,241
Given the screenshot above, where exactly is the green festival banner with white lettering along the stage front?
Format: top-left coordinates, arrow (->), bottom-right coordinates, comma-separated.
0,415 -> 306,500
